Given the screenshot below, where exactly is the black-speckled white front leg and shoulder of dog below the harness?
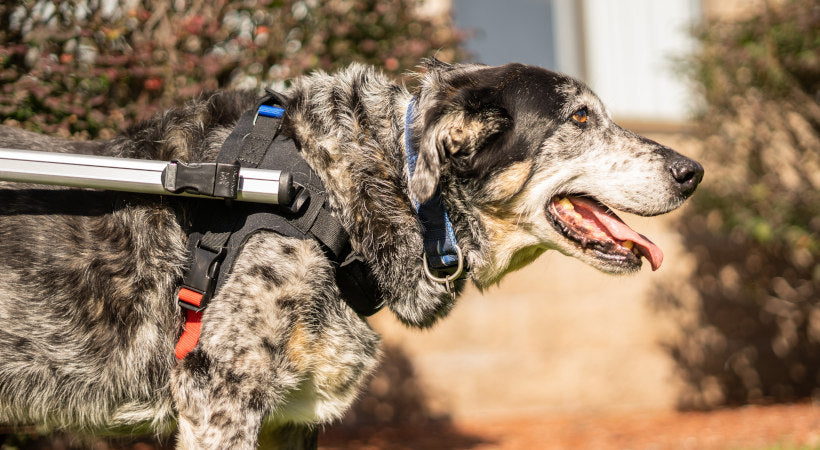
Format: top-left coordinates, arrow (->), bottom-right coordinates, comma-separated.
171,232 -> 378,449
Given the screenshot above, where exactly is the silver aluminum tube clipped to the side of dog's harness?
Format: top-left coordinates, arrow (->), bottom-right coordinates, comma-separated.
0,148 -> 281,204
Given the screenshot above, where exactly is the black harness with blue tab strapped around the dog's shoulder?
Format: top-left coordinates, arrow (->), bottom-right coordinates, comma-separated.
178,91 -> 384,324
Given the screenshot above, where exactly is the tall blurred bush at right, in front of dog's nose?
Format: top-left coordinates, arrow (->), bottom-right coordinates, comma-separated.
656,0 -> 820,408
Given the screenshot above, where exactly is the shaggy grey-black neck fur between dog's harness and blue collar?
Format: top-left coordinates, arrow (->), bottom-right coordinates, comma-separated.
287,65 -> 477,327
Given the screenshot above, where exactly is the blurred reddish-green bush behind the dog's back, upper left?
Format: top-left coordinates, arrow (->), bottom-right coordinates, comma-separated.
0,0 -> 461,138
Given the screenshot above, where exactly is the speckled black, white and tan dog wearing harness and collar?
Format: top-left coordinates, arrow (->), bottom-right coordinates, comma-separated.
0,60 -> 703,449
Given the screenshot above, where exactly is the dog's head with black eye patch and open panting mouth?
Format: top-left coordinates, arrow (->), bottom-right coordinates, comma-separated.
410,61 -> 703,286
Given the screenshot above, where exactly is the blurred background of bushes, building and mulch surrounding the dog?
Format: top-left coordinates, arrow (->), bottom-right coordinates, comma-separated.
0,0 -> 820,449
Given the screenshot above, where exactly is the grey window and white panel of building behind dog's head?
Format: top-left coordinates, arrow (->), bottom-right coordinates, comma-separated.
452,0 -> 701,122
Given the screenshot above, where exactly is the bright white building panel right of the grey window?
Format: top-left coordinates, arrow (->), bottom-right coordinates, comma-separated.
583,0 -> 700,122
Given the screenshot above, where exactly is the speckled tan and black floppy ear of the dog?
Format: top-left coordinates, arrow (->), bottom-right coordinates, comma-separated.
410,103 -> 511,202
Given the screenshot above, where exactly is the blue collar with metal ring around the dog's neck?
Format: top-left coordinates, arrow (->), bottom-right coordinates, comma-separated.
404,97 -> 464,285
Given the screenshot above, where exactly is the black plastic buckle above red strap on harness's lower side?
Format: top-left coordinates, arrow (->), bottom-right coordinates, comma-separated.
177,241 -> 226,312
